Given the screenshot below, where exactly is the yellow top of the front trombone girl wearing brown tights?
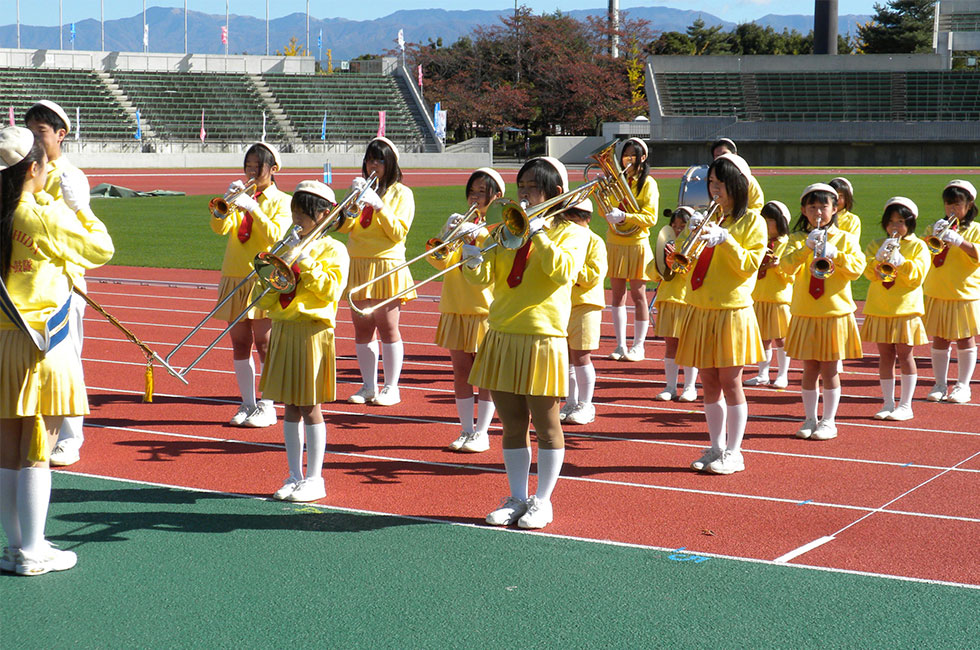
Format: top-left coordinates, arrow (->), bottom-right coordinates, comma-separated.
463,221 -> 589,336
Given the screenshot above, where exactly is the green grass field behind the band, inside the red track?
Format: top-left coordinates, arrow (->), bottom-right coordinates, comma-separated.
92,170 -> 980,299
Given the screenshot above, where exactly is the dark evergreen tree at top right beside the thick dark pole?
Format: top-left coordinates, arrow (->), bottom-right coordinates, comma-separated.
858,0 -> 935,54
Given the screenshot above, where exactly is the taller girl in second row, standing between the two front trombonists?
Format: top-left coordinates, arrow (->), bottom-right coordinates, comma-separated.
341,137 -> 416,406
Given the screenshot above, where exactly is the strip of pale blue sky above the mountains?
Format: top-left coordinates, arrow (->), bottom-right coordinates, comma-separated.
9,0 -> 884,25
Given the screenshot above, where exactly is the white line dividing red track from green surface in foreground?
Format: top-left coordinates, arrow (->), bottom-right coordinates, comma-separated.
57,470 -> 980,590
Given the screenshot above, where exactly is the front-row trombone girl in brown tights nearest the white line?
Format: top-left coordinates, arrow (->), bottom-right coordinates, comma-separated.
463,157 -> 589,528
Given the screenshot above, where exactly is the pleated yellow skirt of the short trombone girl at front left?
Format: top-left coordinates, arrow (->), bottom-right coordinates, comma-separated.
259,320 -> 337,406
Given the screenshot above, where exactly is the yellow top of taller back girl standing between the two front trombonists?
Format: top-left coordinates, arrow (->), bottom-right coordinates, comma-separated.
339,183 -> 415,260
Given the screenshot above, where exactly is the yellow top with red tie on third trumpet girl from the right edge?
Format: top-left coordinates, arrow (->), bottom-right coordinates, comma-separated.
779,226 -> 865,317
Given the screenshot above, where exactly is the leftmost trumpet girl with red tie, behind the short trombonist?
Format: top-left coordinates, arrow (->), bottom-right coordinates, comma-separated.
211,142 -> 289,427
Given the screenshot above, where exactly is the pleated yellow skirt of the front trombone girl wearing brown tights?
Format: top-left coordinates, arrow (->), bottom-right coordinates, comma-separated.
469,329 -> 568,397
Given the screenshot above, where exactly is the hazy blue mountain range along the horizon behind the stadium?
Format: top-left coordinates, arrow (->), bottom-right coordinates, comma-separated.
0,7 -> 871,61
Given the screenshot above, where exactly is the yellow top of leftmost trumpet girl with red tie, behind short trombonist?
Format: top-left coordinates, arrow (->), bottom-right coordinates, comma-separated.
211,183 -> 293,278
